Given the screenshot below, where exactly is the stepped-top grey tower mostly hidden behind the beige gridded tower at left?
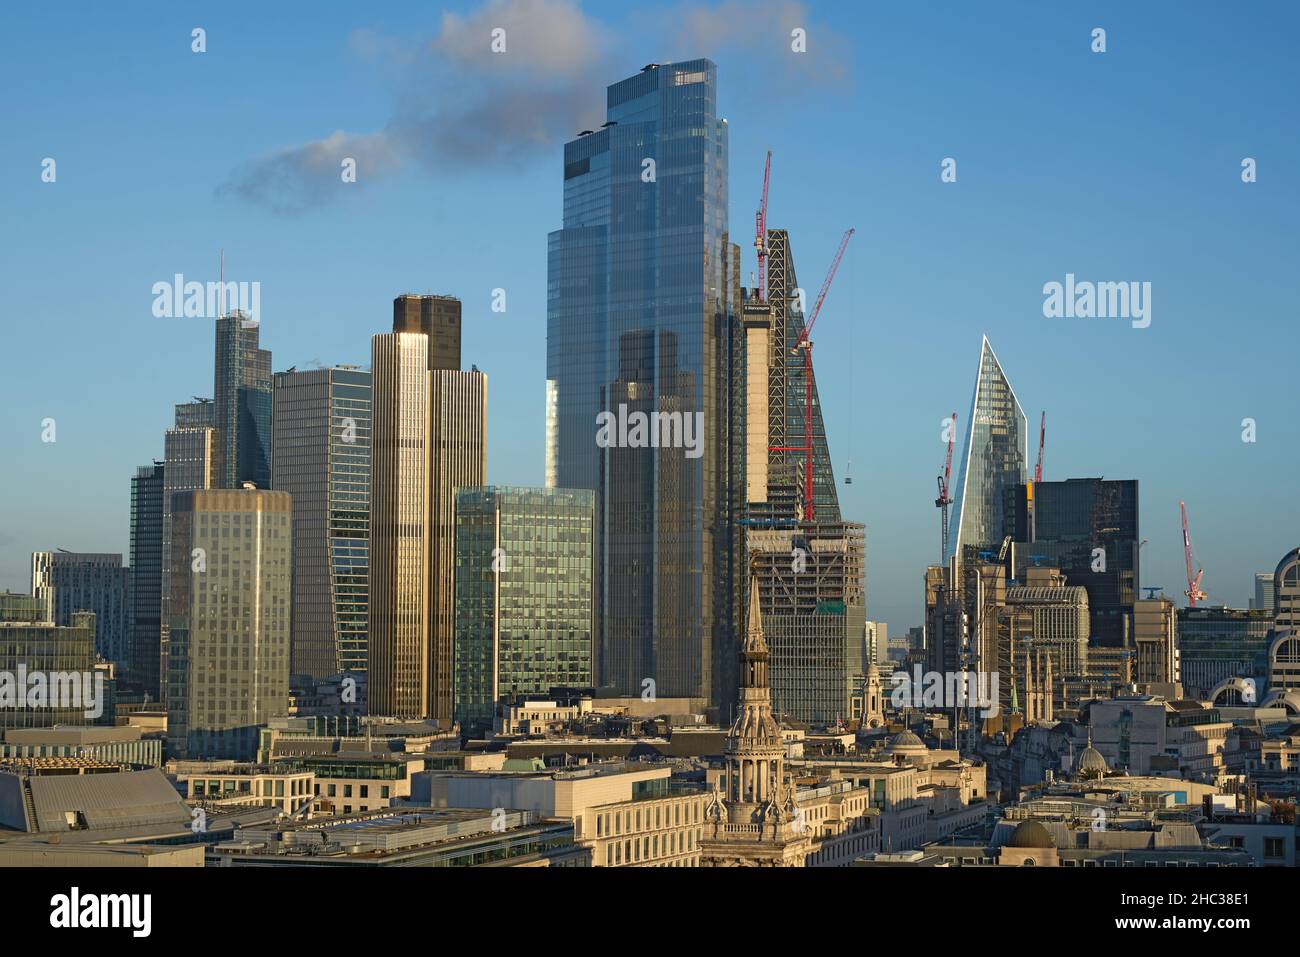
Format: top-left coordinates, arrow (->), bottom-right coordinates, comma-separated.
158,402 -> 221,701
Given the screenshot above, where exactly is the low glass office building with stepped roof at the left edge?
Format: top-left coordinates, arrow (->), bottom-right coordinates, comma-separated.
0,592 -> 96,732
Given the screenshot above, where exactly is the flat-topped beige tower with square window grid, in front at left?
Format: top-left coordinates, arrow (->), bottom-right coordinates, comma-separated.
166,488 -> 293,761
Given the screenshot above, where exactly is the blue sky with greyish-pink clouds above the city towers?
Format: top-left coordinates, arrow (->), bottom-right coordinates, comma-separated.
0,0 -> 1300,632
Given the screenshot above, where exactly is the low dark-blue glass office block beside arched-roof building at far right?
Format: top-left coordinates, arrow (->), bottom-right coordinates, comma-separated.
1178,605 -> 1273,703
